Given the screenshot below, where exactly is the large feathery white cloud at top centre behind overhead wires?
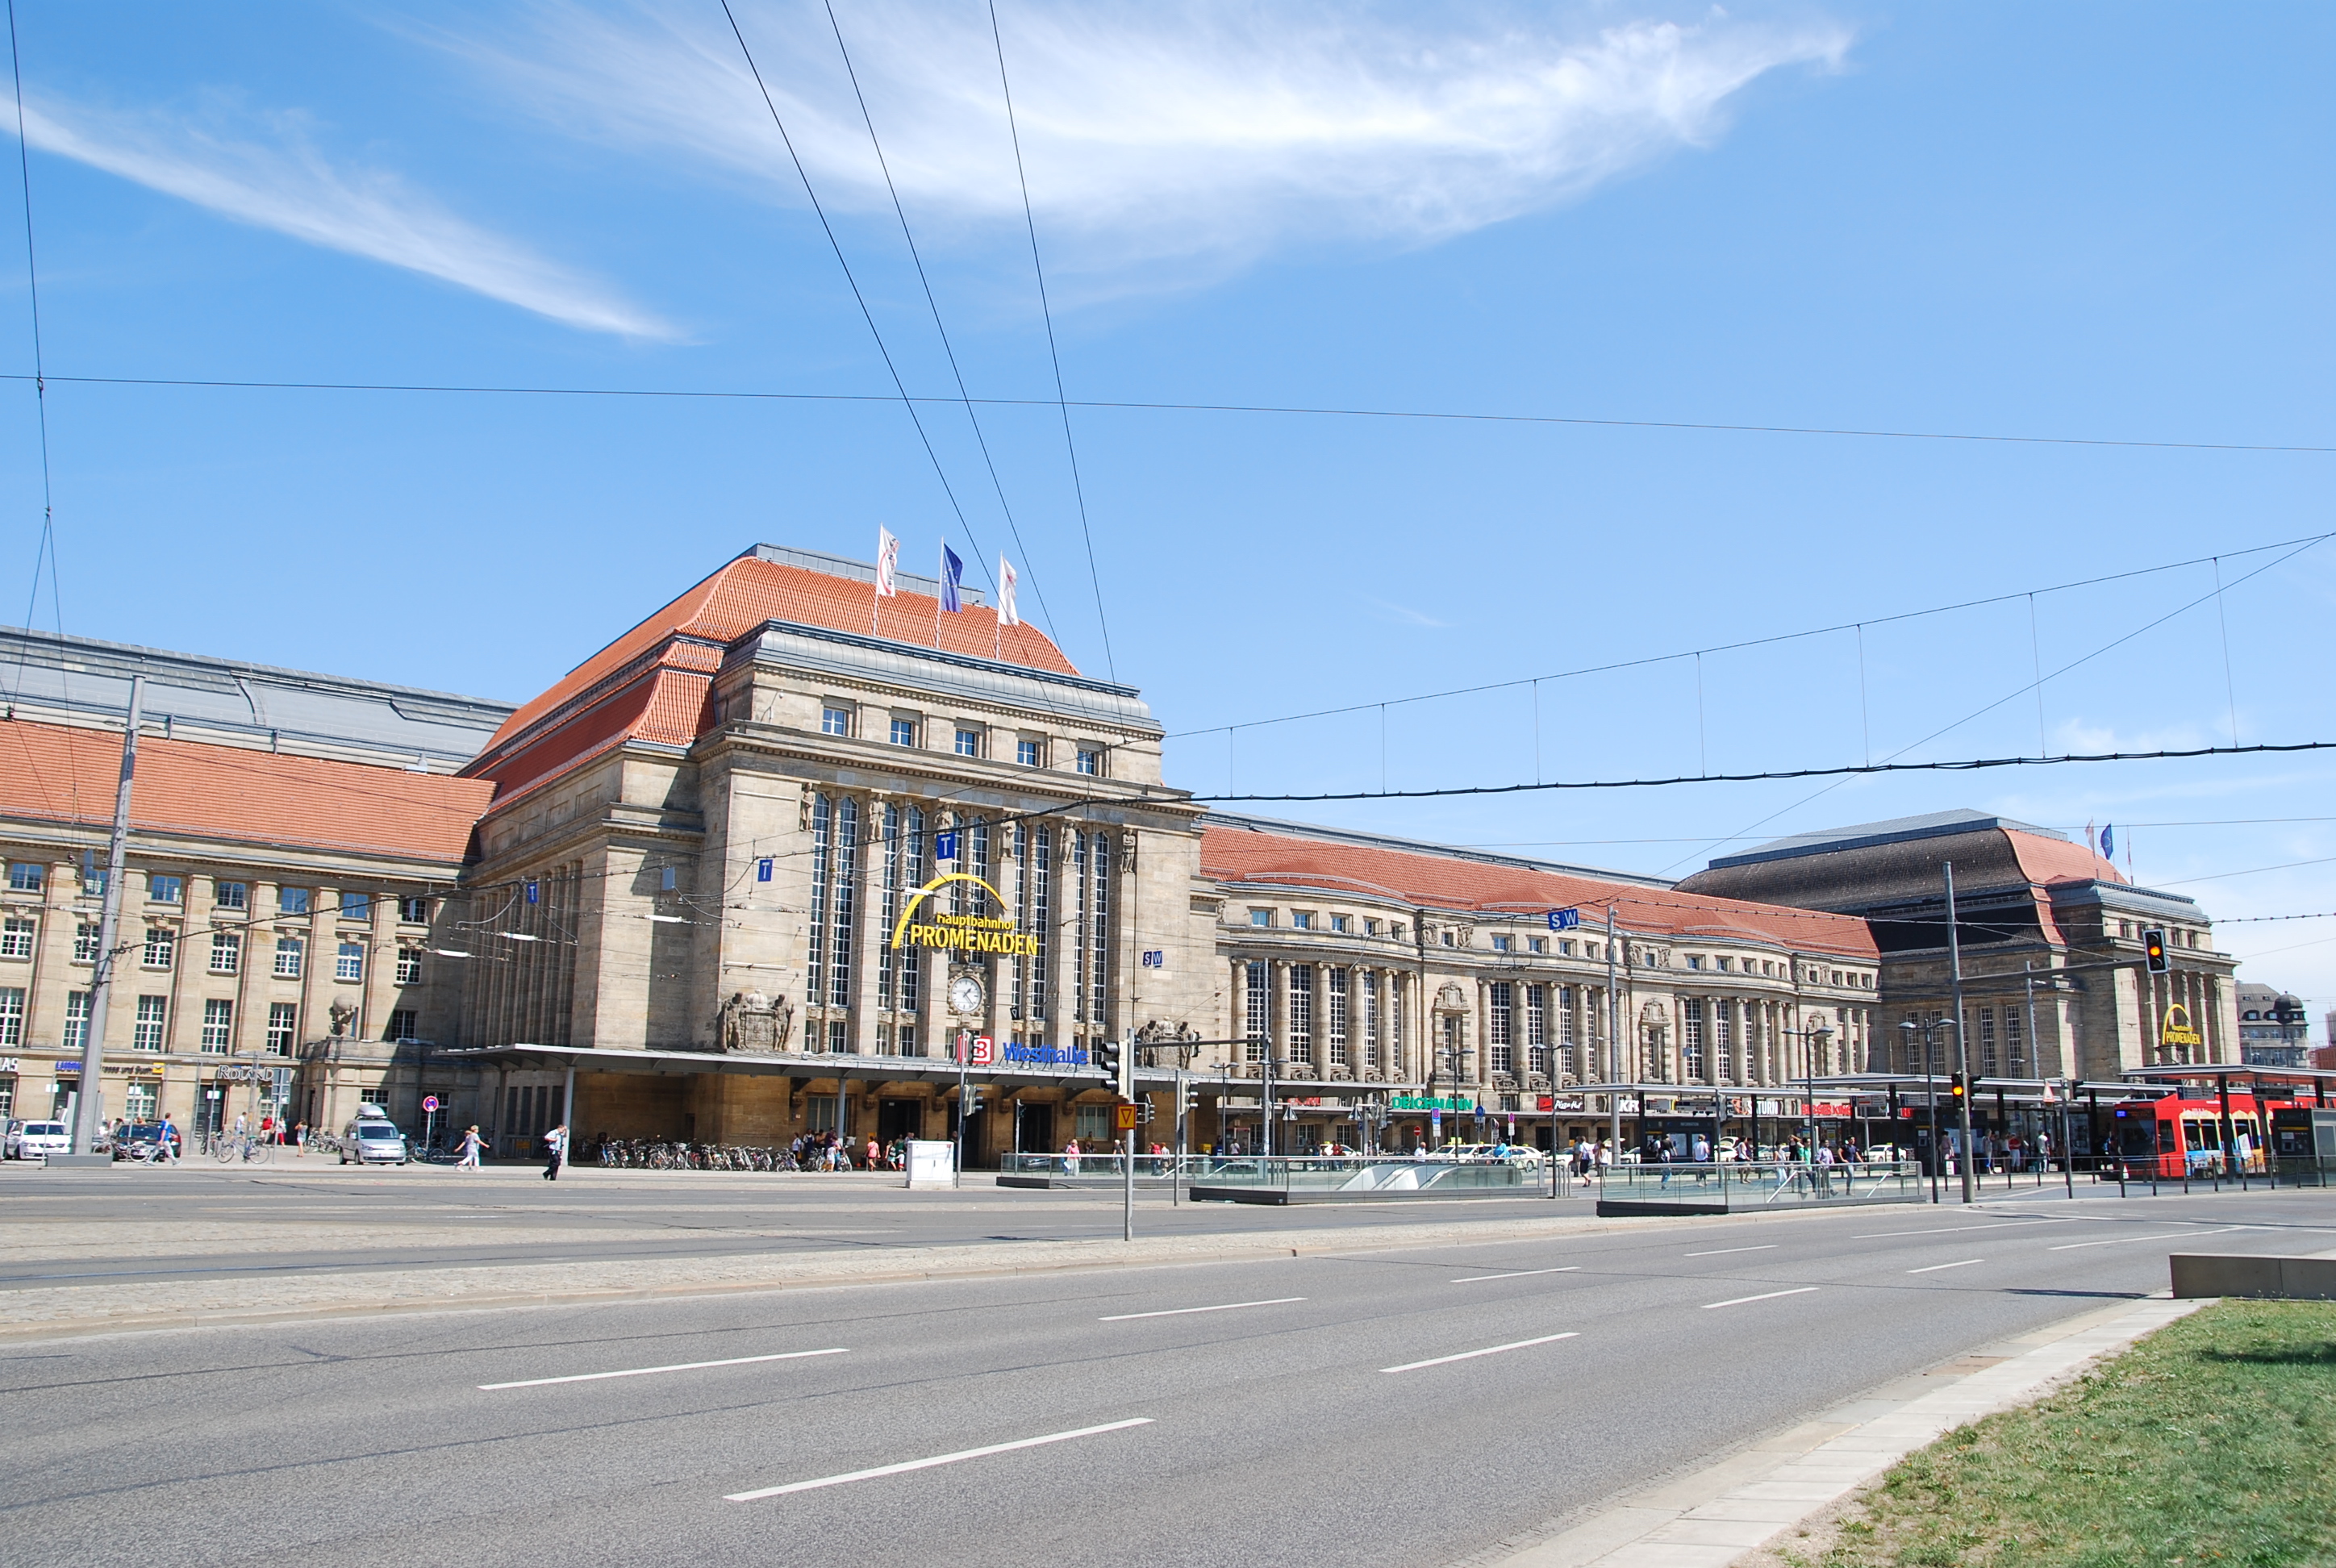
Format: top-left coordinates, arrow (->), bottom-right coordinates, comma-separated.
439,0 -> 1848,286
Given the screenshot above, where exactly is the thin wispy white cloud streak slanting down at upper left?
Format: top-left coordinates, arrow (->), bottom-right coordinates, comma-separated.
23,101 -> 675,339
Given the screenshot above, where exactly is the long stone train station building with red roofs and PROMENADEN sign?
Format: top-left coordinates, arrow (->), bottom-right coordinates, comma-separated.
0,544 -> 2235,1164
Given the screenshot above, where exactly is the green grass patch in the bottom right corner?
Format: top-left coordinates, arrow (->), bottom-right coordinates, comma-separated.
1787,1302 -> 2336,1568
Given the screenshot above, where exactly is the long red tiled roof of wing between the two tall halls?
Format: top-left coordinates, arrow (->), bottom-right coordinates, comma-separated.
1201,823 -> 1878,961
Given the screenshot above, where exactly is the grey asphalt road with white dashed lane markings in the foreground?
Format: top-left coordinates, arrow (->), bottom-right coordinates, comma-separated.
0,1192 -> 2336,1568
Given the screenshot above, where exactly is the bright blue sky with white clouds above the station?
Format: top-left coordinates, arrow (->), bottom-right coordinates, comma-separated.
0,0 -> 2336,1033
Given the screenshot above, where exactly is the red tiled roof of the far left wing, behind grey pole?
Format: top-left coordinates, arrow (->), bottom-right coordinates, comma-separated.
0,719 -> 495,865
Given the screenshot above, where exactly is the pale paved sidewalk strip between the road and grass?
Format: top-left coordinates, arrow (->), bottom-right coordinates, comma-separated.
1493,1297 -> 2208,1568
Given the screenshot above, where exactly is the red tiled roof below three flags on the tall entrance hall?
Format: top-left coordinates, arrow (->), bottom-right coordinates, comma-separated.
472,557 -> 1079,787
